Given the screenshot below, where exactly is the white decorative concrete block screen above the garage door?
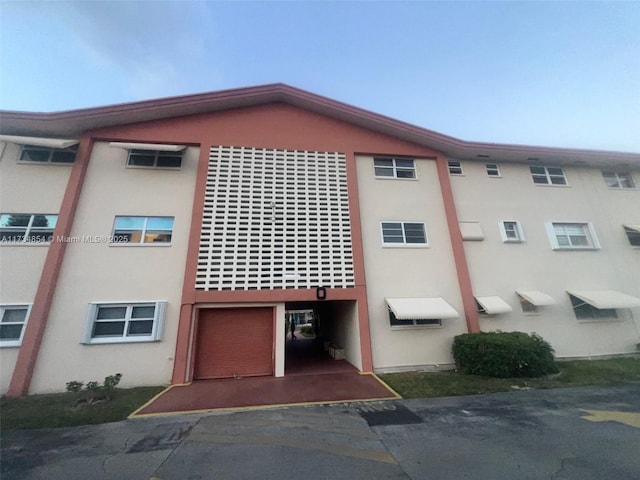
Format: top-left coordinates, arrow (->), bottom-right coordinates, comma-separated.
196,146 -> 355,290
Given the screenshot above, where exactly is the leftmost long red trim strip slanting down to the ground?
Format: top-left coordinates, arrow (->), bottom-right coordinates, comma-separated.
7,136 -> 93,397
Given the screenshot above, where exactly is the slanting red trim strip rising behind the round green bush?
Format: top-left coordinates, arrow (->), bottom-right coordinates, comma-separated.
436,155 -> 480,333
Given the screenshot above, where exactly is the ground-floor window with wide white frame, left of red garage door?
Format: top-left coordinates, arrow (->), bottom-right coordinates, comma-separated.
84,302 -> 166,343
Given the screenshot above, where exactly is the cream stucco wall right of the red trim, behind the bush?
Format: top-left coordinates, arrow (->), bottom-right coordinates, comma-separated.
451,162 -> 640,357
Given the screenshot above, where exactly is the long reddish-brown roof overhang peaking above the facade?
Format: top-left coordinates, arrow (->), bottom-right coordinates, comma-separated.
0,83 -> 640,168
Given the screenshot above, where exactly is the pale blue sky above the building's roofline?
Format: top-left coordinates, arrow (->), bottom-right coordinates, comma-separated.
0,0 -> 640,152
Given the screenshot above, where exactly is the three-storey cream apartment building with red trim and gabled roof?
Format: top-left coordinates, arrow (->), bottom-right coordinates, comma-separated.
0,84 -> 640,395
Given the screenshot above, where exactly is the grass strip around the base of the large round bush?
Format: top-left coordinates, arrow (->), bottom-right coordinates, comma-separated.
379,357 -> 640,398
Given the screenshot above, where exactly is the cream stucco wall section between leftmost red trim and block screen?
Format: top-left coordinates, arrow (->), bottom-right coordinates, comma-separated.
30,143 -> 199,393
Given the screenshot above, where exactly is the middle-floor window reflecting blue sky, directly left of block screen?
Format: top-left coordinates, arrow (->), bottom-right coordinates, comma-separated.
111,217 -> 173,244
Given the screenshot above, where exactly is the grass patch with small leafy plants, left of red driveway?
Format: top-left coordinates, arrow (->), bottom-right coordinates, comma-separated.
0,387 -> 164,430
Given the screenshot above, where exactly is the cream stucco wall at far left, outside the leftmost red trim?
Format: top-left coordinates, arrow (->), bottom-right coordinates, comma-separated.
0,142 -> 71,394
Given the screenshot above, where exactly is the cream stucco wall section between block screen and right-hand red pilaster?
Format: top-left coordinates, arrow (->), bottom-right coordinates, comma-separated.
356,156 -> 466,371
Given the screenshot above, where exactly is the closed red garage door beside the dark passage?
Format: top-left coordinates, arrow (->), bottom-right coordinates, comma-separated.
193,308 -> 273,379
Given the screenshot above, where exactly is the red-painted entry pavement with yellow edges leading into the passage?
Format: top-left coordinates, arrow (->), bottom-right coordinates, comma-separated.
131,338 -> 399,417
